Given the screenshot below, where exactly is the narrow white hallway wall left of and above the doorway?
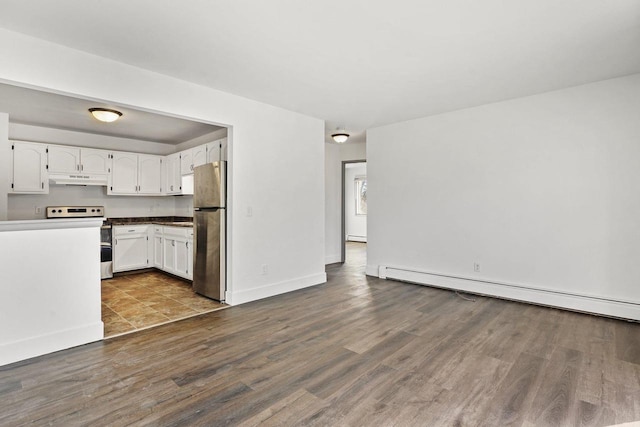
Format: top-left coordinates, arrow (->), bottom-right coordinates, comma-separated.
324,142 -> 367,264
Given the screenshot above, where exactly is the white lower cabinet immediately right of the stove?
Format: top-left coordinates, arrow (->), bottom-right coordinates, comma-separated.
113,224 -> 150,272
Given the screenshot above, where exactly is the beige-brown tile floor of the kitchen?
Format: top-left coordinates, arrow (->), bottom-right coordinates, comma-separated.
102,271 -> 227,338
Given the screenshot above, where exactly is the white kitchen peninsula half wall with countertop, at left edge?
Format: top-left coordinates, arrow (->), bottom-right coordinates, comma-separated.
0,218 -> 104,366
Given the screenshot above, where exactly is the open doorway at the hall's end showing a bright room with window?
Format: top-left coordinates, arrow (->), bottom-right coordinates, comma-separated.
340,159 -> 367,263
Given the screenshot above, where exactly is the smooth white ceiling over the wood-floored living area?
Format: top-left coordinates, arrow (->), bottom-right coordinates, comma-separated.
0,0 -> 640,145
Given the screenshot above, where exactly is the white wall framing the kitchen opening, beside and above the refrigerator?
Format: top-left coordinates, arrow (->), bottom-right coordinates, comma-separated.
0,29 -> 326,304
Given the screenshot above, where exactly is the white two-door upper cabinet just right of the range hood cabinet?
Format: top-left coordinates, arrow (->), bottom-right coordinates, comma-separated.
107,152 -> 162,195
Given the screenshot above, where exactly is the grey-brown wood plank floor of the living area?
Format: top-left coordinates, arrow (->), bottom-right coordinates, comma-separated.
0,243 -> 640,426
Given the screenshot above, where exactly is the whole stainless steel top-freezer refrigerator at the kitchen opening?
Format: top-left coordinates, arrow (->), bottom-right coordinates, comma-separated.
193,161 -> 227,301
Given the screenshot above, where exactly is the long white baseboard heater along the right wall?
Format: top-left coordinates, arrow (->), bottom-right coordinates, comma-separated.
376,266 -> 640,321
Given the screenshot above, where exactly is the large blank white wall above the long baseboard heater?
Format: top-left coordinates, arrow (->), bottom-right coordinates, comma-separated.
367,74 -> 640,317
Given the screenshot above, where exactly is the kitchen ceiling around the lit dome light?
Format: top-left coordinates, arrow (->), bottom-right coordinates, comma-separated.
0,84 -> 221,145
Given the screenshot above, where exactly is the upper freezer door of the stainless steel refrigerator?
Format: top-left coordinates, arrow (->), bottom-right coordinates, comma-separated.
193,161 -> 227,208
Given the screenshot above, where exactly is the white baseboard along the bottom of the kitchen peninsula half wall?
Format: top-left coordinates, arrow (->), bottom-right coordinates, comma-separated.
0,321 -> 104,366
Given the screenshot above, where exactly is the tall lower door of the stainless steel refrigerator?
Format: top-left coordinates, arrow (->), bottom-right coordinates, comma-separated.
193,209 -> 226,301
